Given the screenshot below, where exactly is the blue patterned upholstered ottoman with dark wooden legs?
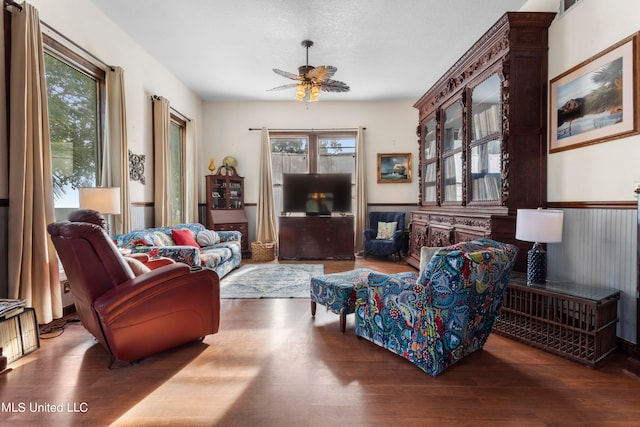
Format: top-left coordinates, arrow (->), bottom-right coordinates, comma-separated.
310,268 -> 375,334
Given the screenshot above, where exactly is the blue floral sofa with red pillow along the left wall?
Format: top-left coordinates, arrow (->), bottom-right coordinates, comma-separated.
113,223 -> 242,278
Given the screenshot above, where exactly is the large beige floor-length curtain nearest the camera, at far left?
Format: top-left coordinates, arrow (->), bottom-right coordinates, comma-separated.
8,2 -> 62,323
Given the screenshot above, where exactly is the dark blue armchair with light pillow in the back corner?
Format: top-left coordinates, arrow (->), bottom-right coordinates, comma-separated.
364,212 -> 405,258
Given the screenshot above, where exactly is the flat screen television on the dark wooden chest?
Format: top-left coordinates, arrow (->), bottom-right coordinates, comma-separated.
282,173 -> 351,215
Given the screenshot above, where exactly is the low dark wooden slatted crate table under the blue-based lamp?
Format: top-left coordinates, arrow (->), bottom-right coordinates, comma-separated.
493,272 -> 620,366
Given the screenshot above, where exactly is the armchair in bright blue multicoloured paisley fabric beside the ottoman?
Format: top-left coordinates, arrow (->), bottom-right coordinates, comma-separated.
356,239 -> 518,376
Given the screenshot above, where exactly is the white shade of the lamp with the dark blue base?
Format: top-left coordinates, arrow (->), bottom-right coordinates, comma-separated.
516,209 -> 564,243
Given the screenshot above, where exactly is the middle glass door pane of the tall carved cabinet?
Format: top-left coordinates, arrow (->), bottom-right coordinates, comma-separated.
442,102 -> 463,202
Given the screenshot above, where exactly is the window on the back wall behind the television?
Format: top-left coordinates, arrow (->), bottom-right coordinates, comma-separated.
271,132 -> 357,216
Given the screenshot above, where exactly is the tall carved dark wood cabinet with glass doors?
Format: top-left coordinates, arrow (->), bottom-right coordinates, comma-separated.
407,12 -> 555,271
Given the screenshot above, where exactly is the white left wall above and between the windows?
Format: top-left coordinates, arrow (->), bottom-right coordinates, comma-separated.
21,0 -> 202,203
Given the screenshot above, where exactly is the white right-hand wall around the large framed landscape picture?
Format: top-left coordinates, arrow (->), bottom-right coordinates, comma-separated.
521,0 -> 640,202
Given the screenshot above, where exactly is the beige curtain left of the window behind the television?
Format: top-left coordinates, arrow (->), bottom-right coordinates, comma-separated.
256,127 -> 278,243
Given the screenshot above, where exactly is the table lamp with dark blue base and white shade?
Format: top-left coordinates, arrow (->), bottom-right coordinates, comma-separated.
516,208 -> 564,284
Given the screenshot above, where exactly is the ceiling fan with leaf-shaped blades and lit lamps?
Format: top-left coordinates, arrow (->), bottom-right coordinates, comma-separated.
269,40 -> 350,102
